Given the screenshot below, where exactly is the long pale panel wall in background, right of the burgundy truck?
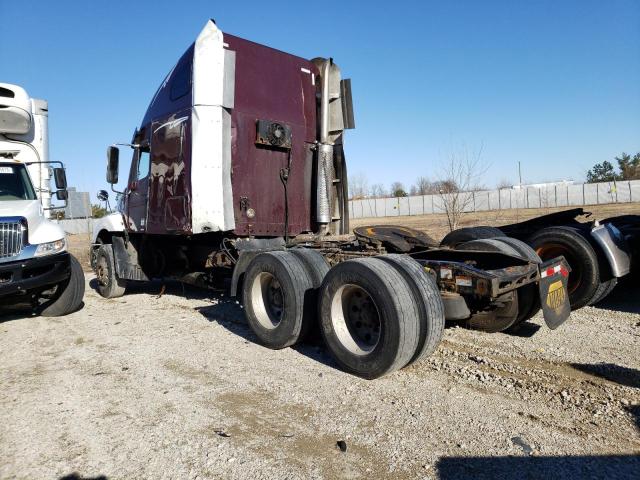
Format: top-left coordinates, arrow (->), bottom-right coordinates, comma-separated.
349,180 -> 640,218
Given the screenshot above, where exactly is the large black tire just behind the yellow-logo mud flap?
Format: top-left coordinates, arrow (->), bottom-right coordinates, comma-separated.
527,226 -> 600,310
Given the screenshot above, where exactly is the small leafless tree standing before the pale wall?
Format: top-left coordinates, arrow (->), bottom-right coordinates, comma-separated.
438,146 -> 487,231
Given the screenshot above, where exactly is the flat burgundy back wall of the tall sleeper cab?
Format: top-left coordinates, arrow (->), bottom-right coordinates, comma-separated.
224,34 -> 317,236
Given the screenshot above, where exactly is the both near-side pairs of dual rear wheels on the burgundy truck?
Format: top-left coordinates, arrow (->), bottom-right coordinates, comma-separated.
243,249 -> 444,379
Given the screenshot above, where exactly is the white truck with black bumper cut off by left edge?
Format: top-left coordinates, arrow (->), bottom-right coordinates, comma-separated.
0,83 -> 85,316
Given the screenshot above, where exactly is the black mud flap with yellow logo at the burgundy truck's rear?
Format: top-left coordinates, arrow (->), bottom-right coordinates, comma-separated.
539,257 -> 571,330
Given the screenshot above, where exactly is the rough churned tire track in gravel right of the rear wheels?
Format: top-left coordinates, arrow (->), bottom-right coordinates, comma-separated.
408,340 -> 640,451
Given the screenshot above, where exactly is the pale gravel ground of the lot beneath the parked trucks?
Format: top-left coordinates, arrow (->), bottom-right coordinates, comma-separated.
0,274 -> 640,480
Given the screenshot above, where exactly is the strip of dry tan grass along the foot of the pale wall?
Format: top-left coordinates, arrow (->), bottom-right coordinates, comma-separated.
351,202 -> 640,240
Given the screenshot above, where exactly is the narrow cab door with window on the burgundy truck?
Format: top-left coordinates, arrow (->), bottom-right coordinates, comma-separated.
127,144 -> 151,232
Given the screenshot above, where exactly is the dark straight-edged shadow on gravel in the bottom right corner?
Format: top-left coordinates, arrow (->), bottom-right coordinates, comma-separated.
436,455 -> 640,480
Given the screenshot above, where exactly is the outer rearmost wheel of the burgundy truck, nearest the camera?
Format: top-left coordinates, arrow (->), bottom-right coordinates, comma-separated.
319,258 -> 420,379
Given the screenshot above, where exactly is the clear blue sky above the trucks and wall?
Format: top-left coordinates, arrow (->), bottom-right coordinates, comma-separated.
0,0 -> 640,201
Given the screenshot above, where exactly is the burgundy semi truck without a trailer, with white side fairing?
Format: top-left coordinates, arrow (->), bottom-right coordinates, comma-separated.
92,21 -> 569,378
